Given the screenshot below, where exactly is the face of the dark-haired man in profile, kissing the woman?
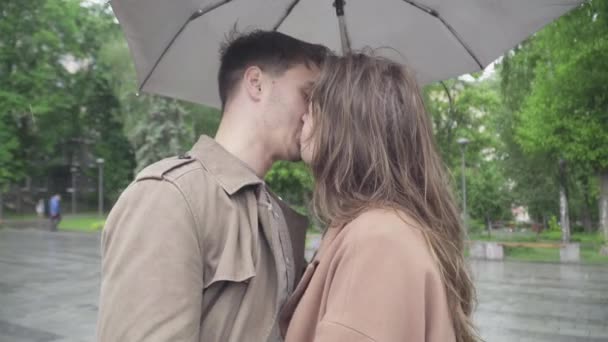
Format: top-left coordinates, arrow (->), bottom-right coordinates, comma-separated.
264,64 -> 319,161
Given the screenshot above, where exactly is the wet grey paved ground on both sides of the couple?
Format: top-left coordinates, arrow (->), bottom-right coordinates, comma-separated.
0,229 -> 608,342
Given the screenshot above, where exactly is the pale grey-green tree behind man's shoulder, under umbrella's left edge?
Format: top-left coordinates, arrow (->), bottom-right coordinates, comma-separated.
100,32 -> 220,171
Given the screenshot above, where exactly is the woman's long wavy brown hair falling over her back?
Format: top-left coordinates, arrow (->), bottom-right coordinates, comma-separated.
309,53 -> 479,342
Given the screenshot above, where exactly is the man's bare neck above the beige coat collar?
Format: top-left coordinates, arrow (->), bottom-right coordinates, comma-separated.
215,117 -> 274,179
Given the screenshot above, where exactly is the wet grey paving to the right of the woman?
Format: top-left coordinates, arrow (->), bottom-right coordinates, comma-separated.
472,262 -> 608,342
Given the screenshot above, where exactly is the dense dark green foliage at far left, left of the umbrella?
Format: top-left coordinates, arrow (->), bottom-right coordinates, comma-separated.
0,0 -> 133,204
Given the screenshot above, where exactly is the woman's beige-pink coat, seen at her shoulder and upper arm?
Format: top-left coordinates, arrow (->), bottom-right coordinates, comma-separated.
281,210 -> 455,342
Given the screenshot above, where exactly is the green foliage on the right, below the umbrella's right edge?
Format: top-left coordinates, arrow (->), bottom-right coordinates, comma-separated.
500,0 -> 608,232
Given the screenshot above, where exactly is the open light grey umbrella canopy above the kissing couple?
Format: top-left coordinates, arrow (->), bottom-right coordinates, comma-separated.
111,0 -> 583,106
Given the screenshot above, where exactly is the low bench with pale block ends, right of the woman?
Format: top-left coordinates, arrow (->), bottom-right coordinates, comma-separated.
469,241 -> 581,263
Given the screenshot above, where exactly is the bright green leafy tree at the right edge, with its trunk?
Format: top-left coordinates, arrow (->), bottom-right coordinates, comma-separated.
517,1 -> 608,244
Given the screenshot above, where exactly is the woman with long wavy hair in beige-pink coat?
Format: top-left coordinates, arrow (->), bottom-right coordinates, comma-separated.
281,54 -> 477,342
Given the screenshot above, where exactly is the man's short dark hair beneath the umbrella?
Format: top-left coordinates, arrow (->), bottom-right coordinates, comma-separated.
217,30 -> 329,108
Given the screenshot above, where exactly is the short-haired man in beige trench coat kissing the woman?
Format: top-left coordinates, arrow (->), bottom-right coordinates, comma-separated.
97,31 -> 327,342
